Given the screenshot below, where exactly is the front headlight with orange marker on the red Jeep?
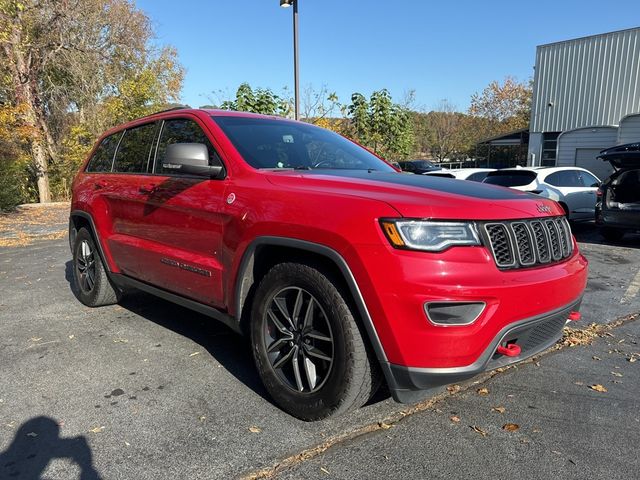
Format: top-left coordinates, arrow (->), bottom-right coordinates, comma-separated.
380,219 -> 480,252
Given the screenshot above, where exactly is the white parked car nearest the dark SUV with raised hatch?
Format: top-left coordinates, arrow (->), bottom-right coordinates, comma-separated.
483,167 -> 600,220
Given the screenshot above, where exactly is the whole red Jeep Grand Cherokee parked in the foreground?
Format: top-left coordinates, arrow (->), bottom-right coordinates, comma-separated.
70,109 -> 587,420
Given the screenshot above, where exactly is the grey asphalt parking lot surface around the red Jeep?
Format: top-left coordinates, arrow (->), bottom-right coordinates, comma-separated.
0,207 -> 640,480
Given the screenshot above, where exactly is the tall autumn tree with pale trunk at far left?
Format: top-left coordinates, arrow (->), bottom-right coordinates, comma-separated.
0,0 -> 183,202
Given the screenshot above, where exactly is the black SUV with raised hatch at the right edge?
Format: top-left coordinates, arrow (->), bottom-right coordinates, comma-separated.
596,142 -> 640,241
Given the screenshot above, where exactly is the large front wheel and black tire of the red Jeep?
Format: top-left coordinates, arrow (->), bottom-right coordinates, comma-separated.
251,263 -> 381,420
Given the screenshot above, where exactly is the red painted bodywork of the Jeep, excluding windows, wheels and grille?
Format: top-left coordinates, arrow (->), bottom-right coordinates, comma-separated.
72,111 -> 587,376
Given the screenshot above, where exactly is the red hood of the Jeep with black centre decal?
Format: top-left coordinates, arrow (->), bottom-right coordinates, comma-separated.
267,170 -> 564,220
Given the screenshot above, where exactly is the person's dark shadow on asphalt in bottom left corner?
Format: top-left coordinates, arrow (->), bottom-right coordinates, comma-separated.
0,416 -> 101,480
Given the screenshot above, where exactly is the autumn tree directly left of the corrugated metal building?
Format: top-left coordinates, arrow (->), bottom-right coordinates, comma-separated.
469,77 -> 532,137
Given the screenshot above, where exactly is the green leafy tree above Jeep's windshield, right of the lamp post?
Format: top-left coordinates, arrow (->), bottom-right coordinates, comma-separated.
345,89 -> 414,160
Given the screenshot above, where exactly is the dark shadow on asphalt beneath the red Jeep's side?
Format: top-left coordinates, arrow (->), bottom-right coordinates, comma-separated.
65,261 -> 271,402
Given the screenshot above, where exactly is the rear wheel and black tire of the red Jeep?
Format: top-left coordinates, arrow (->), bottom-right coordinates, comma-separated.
72,228 -> 119,307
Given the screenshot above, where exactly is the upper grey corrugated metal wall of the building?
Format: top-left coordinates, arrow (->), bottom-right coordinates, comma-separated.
530,28 -> 640,132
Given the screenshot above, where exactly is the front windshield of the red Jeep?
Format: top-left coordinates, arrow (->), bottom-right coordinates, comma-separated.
212,116 -> 395,172
